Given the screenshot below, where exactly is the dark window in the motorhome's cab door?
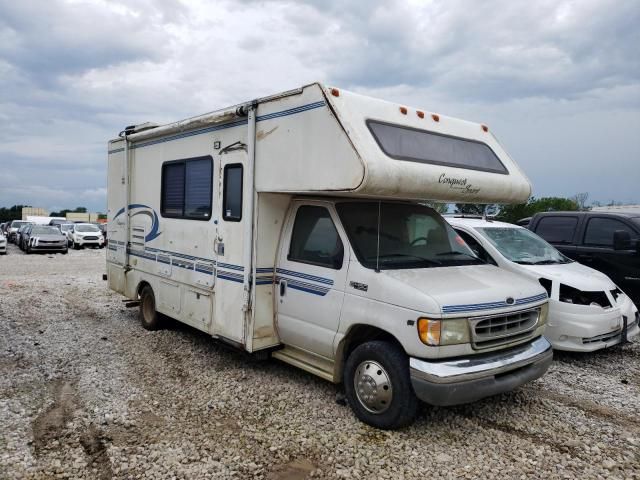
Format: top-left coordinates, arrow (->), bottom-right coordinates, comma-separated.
287,205 -> 344,270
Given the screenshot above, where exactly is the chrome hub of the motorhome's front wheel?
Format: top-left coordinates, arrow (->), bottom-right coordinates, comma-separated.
353,360 -> 393,413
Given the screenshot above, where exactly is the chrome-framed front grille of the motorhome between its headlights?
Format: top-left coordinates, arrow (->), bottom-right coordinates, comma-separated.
469,308 -> 540,350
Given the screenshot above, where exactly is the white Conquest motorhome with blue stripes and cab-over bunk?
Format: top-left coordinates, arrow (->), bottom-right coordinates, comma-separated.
107,83 -> 552,428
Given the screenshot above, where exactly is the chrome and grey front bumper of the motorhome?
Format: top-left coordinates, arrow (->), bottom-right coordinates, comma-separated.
409,337 -> 553,406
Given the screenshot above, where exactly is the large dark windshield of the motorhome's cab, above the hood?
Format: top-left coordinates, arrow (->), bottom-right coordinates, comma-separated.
336,202 -> 485,270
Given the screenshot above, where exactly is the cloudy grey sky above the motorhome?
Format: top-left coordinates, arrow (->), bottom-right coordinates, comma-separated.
0,0 -> 640,211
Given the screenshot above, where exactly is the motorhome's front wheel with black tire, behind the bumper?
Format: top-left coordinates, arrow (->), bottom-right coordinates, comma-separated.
344,340 -> 418,430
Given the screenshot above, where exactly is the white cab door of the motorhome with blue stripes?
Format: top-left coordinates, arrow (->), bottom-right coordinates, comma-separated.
275,201 -> 349,358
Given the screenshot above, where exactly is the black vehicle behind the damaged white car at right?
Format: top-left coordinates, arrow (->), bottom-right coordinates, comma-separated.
528,212 -> 640,306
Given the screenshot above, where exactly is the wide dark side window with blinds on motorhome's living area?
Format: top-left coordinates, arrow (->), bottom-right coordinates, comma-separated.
160,156 -> 213,220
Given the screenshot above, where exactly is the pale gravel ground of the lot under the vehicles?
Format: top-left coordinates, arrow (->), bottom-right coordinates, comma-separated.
0,245 -> 640,480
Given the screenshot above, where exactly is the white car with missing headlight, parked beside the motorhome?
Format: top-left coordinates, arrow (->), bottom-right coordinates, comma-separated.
447,217 -> 640,352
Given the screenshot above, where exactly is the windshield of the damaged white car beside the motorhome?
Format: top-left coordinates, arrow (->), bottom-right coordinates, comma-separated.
476,227 -> 573,265
